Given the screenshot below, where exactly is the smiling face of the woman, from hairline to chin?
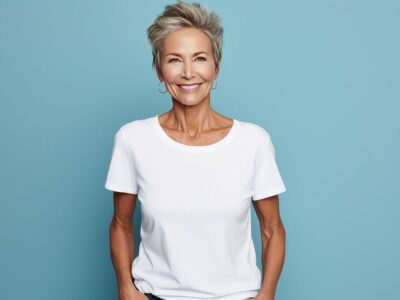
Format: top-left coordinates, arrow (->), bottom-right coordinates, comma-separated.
157,28 -> 218,105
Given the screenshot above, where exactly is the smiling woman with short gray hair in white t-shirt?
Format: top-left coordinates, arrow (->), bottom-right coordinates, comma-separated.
105,1 -> 286,300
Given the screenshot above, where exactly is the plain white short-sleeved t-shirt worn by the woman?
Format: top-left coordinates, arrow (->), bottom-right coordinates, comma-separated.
105,115 -> 286,300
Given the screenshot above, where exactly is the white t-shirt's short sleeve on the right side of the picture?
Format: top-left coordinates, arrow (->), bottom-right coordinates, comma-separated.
252,129 -> 286,201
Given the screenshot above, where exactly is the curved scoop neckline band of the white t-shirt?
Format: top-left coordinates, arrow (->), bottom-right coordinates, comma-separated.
153,114 -> 238,152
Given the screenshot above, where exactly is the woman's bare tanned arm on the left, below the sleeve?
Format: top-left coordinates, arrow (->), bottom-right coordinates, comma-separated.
109,192 -> 147,300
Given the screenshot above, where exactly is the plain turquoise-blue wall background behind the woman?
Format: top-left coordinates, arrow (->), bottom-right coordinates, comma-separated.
0,0 -> 400,300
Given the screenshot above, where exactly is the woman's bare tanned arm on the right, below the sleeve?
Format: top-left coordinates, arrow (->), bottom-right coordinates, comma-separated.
253,195 -> 286,300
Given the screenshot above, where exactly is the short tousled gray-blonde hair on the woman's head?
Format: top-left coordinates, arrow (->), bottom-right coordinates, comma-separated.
147,0 -> 224,74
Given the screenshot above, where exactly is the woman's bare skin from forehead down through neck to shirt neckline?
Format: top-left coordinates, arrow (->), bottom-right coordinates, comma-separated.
157,28 -> 233,146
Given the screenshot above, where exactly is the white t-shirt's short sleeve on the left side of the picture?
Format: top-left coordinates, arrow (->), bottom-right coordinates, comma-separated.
104,127 -> 138,194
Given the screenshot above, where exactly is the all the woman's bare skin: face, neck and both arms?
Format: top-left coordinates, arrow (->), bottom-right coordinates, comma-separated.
109,28 -> 285,300
